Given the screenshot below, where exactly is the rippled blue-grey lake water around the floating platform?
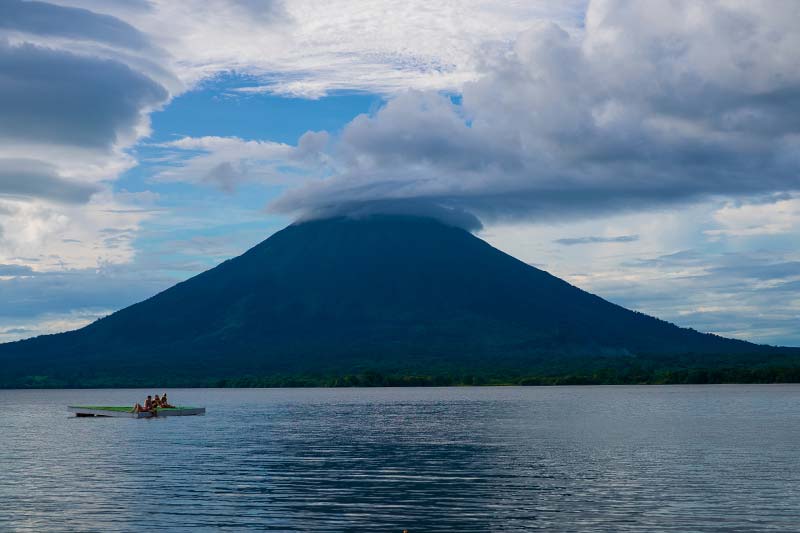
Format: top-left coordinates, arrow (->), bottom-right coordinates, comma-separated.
0,385 -> 800,533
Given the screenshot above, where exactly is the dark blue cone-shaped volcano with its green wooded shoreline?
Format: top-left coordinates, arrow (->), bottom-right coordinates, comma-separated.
0,215 -> 800,388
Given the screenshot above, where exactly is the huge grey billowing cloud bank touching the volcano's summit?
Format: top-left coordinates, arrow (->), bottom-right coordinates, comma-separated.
273,0 -> 800,220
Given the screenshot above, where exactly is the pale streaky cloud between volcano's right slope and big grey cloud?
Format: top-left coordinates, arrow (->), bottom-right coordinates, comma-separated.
480,202 -> 800,346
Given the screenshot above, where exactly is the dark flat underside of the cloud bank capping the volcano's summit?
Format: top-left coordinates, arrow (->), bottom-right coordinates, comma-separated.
268,169 -> 768,222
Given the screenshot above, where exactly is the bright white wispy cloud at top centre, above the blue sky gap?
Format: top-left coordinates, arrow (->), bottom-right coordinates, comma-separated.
51,0 -> 585,97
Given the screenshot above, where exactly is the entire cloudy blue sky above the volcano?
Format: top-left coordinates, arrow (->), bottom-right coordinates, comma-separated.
0,0 -> 800,346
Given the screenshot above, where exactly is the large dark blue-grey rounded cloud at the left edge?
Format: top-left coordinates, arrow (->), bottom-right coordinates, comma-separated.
0,40 -> 168,149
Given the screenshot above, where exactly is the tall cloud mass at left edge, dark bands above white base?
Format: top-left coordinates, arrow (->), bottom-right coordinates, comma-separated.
0,0 -> 177,278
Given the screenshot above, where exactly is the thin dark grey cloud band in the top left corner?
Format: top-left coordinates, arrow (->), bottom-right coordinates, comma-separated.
0,0 -> 149,49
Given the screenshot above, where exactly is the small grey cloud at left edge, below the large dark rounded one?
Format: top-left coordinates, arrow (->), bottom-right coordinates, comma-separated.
0,159 -> 100,204
